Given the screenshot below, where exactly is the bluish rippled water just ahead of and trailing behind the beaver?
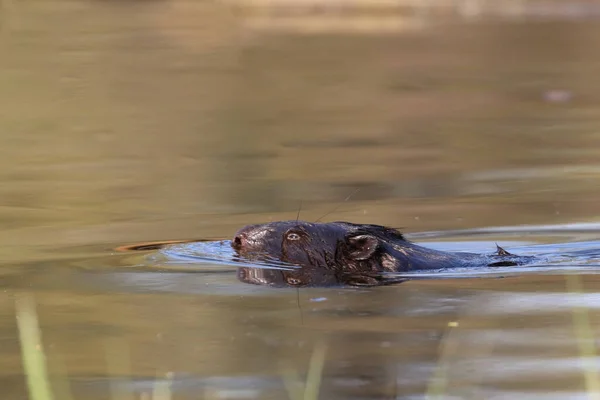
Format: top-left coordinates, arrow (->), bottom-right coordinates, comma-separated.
118,223 -> 600,279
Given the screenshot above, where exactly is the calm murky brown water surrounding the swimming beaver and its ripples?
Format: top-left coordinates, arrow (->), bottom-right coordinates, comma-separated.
0,0 -> 600,399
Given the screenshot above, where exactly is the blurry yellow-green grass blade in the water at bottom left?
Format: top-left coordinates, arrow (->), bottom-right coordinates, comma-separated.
15,294 -> 53,400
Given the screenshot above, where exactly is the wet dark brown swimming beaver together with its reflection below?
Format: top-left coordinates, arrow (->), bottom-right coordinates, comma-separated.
231,221 -> 531,286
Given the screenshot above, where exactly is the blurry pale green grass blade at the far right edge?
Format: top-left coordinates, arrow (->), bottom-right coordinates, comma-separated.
566,275 -> 600,400
